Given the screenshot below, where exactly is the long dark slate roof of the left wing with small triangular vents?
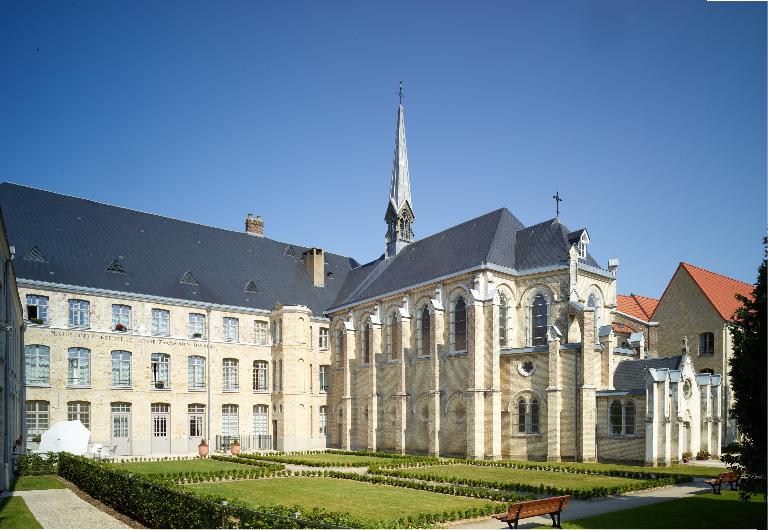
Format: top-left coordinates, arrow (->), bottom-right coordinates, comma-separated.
0,183 -> 359,315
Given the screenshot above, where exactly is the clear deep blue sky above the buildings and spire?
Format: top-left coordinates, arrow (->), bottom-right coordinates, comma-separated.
0,0 -> 766,296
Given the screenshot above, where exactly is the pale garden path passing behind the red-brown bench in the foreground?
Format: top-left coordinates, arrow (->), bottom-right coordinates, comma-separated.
445,478 -> 710,529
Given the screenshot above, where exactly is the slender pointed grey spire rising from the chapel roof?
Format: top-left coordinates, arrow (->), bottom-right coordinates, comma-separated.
384,81 -> 414,258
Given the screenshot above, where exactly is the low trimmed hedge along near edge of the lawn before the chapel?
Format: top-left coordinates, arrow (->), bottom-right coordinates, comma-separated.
372,462 -> 687,499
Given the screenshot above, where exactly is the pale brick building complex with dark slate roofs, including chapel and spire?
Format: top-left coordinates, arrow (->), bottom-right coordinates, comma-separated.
0,94 -> 720,465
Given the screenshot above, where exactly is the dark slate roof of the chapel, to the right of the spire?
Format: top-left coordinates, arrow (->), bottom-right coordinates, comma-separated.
334,208 -> 598,307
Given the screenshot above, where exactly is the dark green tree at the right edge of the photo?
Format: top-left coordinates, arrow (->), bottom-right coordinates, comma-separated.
723,238 -> 768,499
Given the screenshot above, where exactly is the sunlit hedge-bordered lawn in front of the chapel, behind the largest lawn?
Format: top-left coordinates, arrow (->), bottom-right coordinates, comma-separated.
390,464 -> 642,488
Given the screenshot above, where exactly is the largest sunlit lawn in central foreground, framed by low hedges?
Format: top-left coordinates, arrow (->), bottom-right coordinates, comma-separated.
186,477 -> 503,523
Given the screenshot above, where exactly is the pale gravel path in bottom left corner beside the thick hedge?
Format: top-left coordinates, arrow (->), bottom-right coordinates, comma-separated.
13,489 -> 130,528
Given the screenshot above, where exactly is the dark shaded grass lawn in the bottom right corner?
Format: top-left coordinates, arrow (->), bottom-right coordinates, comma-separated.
563,491 -> 766,530
